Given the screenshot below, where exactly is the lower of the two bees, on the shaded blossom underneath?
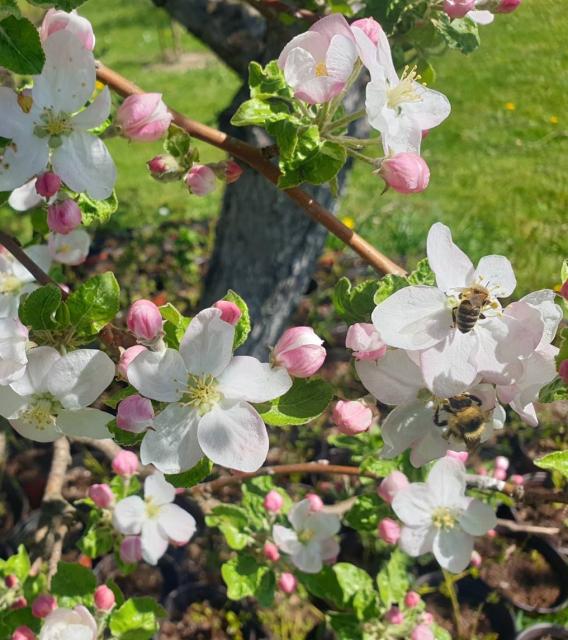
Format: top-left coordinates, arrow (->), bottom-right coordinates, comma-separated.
434,393 -> 487,452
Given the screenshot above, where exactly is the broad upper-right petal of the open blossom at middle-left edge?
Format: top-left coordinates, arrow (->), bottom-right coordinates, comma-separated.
47,349 -> 115,409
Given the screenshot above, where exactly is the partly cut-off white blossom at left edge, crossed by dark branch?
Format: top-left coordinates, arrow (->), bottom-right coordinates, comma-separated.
0,245 -> 51,318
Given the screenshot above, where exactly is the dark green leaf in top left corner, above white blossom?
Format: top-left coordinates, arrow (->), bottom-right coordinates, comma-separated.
0,15 -> 45,74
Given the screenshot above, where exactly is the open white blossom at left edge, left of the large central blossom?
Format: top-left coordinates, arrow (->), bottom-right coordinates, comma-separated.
0,347 -> 114,442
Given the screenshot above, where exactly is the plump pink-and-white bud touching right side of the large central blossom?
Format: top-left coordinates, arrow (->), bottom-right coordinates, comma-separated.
272,327 -> 326,378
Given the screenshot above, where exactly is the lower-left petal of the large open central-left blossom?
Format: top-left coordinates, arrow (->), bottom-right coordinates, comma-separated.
140,404 -> 203,473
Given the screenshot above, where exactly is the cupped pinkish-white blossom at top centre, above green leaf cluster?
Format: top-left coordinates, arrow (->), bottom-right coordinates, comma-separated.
278,13 -> 357,104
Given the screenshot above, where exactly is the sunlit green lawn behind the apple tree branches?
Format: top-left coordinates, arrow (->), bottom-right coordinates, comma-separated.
0,0 -> 568,292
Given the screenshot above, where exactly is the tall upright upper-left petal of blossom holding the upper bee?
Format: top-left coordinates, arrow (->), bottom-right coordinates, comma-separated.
427,222 -> 474,293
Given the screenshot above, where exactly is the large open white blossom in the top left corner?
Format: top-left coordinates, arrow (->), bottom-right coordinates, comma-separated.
0,31 -> 116,200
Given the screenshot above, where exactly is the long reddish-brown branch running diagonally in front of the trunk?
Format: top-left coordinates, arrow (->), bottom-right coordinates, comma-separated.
97,63 -> 406,275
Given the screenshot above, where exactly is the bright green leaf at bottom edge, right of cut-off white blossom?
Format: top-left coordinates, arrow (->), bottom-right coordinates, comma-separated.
109,597 -> 166,640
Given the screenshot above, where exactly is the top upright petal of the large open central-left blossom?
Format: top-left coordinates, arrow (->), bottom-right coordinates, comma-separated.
179,308 -> 235,377
